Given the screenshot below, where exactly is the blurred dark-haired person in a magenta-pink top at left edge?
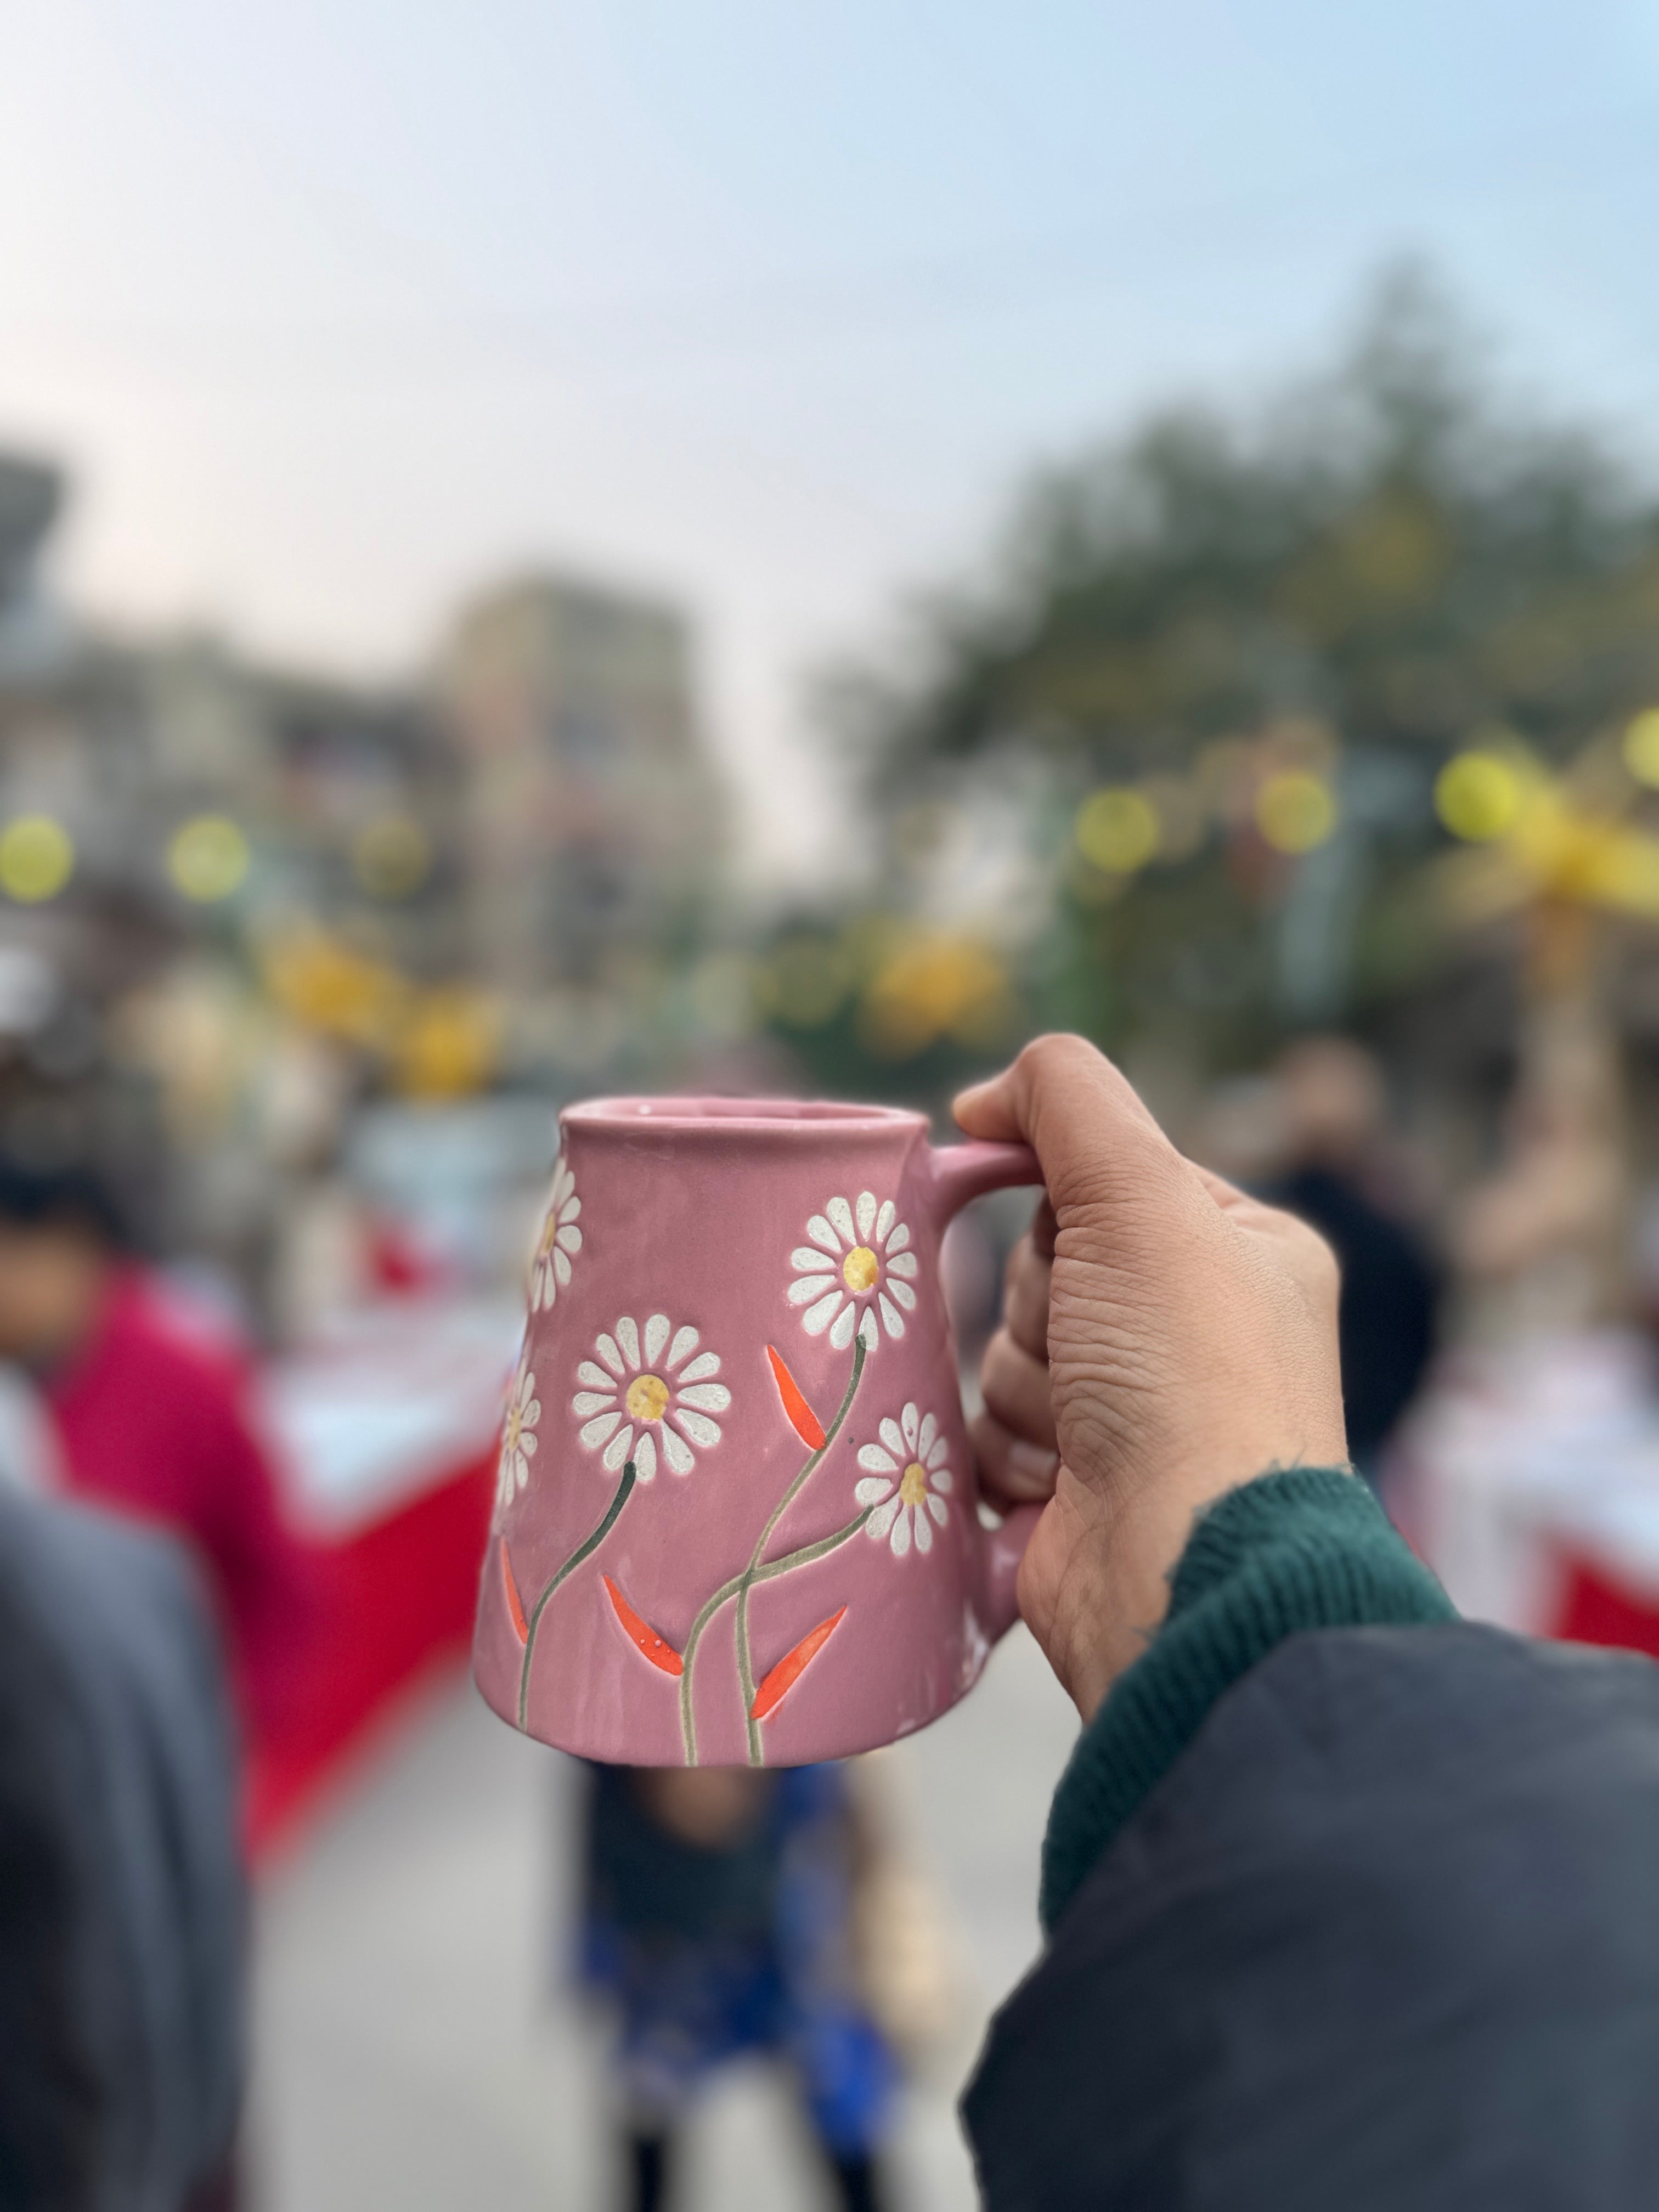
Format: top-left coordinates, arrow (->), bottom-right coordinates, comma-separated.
0,1159 -> 314,1736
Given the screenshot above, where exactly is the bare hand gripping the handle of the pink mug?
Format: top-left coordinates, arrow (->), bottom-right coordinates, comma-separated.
956,1037 -> 1347,1721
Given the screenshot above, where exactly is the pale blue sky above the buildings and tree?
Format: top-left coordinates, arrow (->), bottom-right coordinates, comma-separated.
0,0 -> 1659,862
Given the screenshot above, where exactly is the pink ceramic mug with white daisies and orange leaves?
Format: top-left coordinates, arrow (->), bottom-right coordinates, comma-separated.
473,1097 -> 1042,1765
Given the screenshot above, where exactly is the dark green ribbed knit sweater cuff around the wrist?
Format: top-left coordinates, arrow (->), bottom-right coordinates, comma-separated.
1040,1466 -> 1455,1933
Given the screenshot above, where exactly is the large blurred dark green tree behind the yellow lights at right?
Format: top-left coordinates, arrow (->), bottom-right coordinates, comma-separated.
783,272 -> 1659,1088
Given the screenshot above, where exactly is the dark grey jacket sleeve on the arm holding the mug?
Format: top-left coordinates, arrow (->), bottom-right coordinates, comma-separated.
964,1623 -> 1659,2212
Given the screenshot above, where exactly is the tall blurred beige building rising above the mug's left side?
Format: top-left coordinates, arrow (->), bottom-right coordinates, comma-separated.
436,577 -> 723,991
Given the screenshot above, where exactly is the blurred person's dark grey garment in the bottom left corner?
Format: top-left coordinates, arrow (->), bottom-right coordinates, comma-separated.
0,1487 -> 246,2212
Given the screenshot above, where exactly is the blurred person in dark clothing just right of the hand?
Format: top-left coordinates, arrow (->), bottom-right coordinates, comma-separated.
1261,1037 -> 1440,1482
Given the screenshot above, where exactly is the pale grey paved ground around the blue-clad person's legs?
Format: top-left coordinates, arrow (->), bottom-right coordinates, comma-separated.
252,1628 -> 1075,2212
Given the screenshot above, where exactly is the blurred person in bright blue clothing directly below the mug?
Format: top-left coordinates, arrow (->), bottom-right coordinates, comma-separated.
579,1765 -> 896,2212
